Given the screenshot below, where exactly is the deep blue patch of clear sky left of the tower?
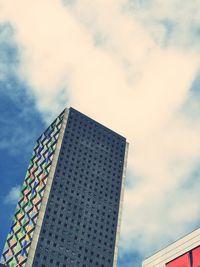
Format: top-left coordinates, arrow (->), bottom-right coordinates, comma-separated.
0,23 -> 45,251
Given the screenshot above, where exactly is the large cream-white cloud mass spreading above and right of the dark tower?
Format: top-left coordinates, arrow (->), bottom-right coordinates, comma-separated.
0,0 -> 200,264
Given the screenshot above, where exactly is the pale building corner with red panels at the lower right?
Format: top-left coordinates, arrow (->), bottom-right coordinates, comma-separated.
142,228 -> 200,267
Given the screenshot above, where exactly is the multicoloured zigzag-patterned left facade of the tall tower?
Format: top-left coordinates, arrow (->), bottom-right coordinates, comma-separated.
1,111 -> 64,267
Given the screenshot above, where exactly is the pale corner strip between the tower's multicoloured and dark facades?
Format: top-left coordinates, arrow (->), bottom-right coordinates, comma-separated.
26,108 -> 69,267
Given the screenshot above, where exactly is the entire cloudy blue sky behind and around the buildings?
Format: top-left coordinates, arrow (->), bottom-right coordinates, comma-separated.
0,0 -> 200,267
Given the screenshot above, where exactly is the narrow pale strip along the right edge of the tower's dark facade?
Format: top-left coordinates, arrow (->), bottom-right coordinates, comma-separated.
113,142 -> 129,267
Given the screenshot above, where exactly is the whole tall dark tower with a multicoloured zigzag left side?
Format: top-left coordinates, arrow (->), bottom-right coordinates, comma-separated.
1,108 -> 128,267
